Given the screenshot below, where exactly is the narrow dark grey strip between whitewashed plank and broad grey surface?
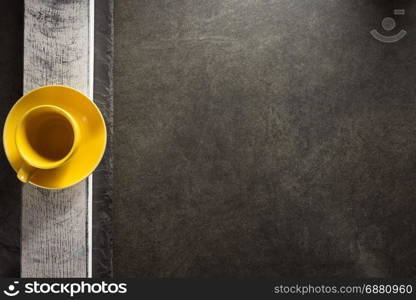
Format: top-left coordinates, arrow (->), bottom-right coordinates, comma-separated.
92,0 -> 113,277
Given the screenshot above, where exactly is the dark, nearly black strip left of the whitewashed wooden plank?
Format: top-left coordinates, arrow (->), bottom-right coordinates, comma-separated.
0,0 -> 23,277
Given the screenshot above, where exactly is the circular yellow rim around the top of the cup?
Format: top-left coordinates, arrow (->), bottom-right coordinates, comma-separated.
15,104 -> 80,170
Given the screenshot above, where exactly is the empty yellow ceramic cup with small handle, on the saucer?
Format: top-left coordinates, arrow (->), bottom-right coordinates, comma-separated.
15,105 -> 80,182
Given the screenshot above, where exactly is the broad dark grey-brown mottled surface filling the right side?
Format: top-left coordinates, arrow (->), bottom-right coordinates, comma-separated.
114,0 -> 416,277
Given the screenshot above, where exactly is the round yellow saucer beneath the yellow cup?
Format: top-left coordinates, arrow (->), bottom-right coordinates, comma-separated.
3,85 -> 107,189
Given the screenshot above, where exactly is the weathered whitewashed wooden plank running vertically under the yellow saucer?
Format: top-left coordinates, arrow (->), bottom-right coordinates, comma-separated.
21,0 -> 93,277
